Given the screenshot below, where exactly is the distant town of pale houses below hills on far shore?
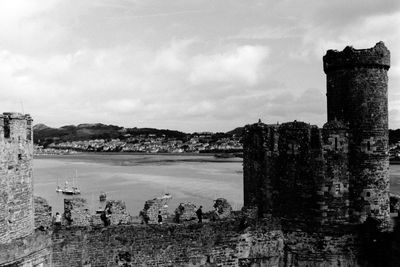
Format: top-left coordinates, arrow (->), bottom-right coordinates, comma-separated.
34,124 -> 243,157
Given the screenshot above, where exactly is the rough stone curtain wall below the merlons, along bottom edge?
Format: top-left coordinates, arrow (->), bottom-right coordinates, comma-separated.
53,221 -> 284,266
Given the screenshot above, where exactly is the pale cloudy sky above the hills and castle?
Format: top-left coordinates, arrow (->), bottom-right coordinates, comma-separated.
0,0 -> 400,132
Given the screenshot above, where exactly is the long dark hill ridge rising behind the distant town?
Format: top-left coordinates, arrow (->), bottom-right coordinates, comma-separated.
33,123 -> 187,146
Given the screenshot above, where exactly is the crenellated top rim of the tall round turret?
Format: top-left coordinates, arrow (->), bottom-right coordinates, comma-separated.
323,42 -> 390,73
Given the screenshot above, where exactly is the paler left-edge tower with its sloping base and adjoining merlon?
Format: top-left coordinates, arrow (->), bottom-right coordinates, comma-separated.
0,113 -> 52,266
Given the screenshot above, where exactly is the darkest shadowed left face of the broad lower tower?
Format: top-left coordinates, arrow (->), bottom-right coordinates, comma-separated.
243,121 -> 325,227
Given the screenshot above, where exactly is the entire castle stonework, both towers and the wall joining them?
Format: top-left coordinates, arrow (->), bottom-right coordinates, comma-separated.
0,43 -> 400,267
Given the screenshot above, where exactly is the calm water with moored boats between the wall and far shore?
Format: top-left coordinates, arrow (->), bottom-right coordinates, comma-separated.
34,154 -> 243,215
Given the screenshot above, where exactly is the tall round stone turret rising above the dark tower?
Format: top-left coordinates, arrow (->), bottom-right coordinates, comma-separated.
324,42 -> 390,228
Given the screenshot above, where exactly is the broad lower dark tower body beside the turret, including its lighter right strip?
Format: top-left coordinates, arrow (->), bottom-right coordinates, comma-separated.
243,121 -> 350,229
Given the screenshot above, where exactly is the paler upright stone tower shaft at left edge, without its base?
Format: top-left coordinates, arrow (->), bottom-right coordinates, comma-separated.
0,113 -> 34,244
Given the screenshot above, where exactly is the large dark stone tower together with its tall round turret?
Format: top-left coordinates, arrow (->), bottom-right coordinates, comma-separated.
243,42 -> 390,228
